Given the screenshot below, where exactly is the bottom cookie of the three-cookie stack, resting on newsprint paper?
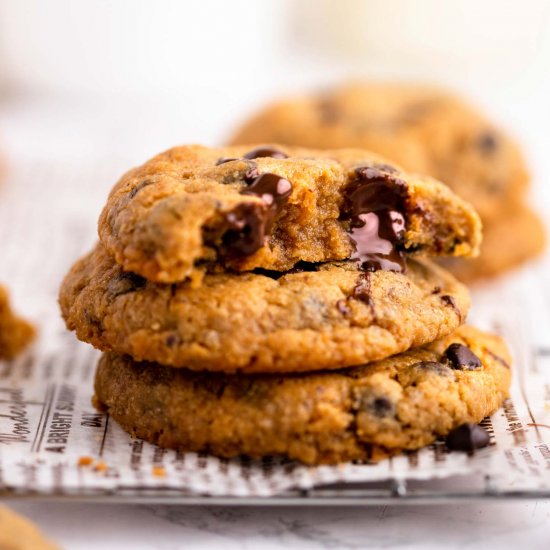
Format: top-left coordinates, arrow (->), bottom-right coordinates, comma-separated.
95,326 -> 511,464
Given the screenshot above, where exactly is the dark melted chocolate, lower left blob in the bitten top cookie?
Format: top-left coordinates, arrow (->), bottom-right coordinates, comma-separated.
222,204 -> 267,256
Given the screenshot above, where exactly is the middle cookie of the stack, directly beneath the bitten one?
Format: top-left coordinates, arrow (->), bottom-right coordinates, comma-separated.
60,246 -> 469,372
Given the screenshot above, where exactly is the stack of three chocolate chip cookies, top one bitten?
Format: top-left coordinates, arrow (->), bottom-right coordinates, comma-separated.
60,145 -> 510,464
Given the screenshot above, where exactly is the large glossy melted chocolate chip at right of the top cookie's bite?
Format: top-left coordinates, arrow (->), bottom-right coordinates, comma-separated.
341,166 -> 407,272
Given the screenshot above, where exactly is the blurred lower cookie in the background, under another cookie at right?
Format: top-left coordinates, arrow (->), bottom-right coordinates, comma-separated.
441,203 -> 546,283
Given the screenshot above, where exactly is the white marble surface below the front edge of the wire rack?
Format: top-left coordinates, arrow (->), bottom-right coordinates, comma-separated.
3,501 -> 550,550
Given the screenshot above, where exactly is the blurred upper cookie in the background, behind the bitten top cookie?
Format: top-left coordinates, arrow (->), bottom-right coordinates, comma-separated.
231,83 -> 528,222
